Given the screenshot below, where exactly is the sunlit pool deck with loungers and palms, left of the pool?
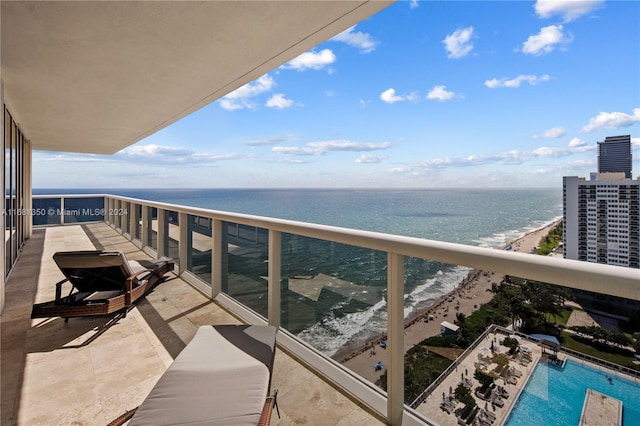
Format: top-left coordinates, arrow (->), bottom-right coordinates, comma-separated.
416,331 -> 542,426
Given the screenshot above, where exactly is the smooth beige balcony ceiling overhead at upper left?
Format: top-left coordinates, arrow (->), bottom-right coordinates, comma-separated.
1,0 -> 393,154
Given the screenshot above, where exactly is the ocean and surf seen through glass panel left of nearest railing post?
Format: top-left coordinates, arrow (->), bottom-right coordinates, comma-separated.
280,233 -> 387,359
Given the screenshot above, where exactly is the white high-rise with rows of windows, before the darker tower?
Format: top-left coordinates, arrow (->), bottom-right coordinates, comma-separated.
563,172 -> 640,268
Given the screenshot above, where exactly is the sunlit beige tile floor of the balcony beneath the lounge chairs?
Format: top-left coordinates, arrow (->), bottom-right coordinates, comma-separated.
0,223 -> 382,426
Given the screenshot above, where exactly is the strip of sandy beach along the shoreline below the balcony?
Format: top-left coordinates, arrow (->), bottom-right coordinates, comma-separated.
338,222 -> 557,383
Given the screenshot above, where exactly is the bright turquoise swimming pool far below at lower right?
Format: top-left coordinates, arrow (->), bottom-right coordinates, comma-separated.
505,360 -> 640,426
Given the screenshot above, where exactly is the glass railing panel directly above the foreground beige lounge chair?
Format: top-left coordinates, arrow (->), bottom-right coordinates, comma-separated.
221,222 -> 269,318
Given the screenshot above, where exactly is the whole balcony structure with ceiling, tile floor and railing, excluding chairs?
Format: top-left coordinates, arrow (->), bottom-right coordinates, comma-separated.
0,0 -> 640,426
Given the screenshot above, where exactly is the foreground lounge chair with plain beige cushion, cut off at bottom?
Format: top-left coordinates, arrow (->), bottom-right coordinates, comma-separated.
109,325 -> 279,426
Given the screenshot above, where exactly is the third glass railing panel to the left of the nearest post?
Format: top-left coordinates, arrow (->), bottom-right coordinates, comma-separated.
187,215 -> 213,285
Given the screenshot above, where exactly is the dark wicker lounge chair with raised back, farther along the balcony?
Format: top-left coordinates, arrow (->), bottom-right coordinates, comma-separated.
31,250 -> 174,321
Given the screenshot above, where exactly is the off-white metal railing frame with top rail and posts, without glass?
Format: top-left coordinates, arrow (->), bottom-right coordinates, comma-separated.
34,194 -> 640,424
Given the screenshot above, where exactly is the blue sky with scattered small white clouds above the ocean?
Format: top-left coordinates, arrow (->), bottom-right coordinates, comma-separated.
33,0 -> 640,188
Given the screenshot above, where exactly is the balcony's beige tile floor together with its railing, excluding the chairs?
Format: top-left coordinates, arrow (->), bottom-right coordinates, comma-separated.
2,194 -> 640,425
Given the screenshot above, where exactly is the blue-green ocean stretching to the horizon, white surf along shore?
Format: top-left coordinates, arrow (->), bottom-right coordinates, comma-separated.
33,189 -> 562,356
